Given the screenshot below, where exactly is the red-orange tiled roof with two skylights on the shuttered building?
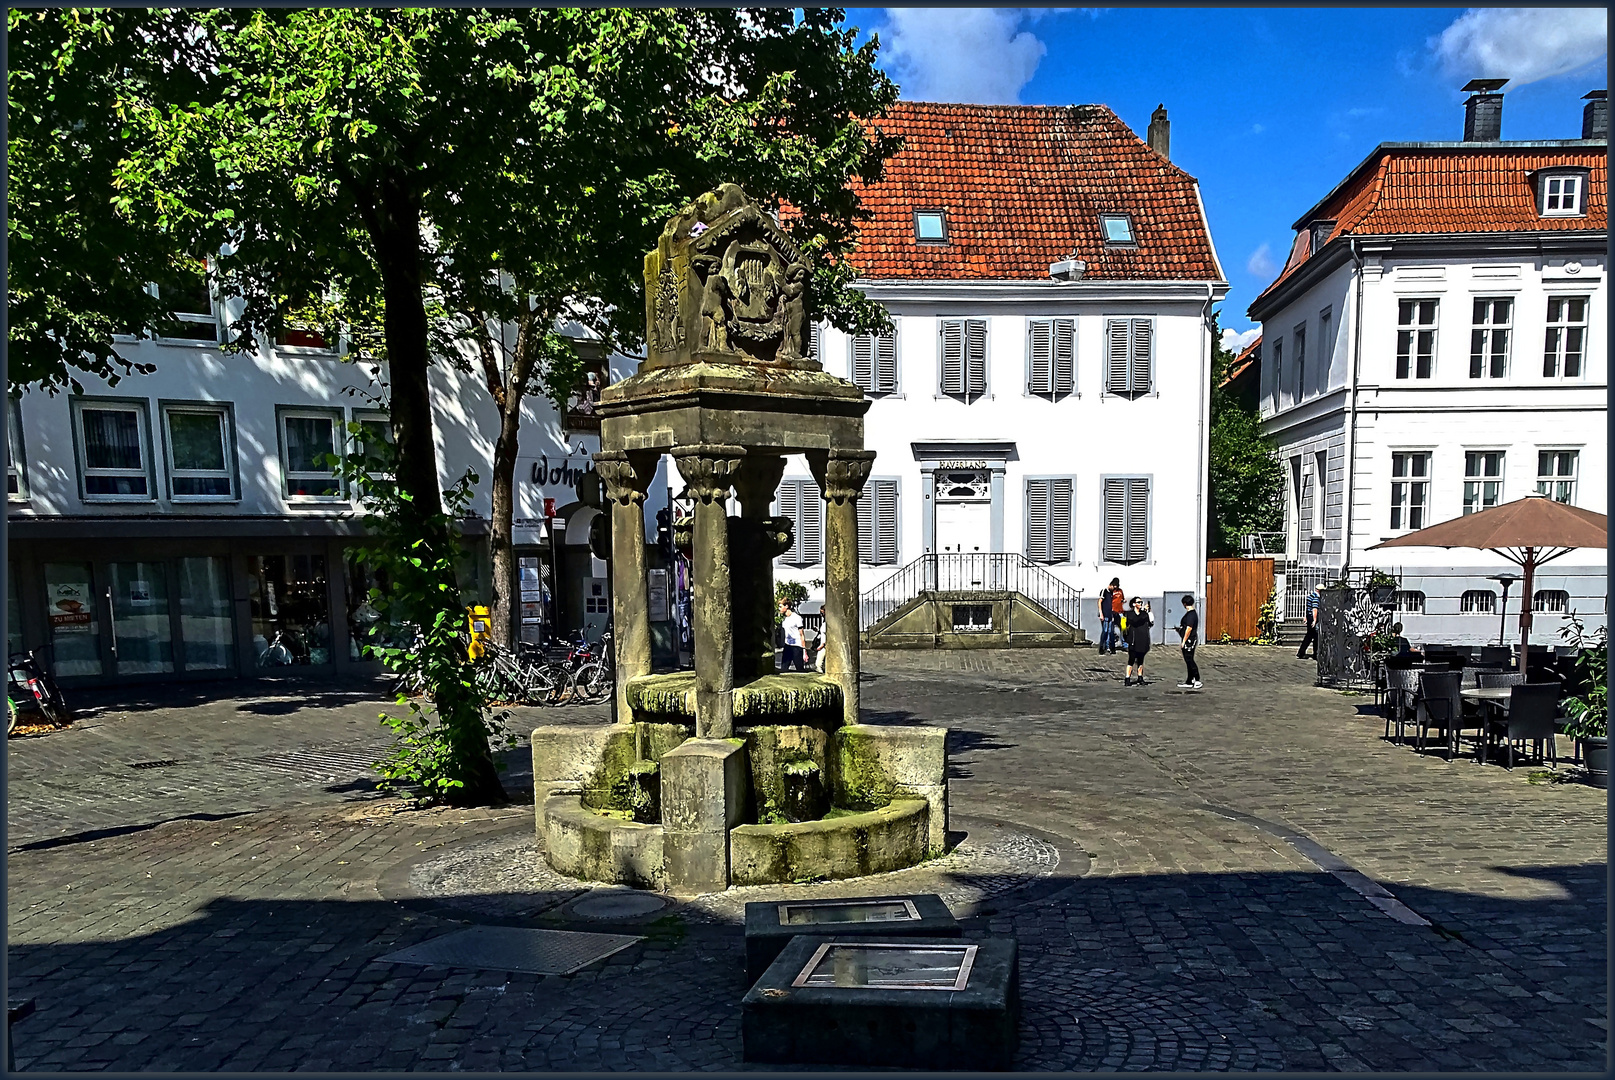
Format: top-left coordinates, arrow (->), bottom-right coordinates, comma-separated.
851,102 -> 1223,281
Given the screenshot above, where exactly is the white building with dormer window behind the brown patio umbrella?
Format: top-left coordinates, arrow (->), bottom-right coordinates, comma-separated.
1250,81 -> 1609,644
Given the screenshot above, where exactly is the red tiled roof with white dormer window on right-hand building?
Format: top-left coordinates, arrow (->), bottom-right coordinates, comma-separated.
1256,142 -> 1609,303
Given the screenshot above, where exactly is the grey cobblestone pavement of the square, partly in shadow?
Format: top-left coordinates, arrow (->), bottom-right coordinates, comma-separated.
8,646 -> 1607,1070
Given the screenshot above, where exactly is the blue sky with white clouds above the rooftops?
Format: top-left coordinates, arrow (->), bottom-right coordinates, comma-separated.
848,8 -> 1609,344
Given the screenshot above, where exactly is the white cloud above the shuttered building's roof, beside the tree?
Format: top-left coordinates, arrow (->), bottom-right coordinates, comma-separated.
880,8 -> 1048,105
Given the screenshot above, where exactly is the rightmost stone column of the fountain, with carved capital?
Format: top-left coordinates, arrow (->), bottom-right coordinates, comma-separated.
808,450 -> 875,723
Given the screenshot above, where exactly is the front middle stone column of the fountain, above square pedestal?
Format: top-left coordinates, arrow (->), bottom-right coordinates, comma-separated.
673,446 -> 746,739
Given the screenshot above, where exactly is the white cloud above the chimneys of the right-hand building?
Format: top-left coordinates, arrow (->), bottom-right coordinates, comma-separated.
1429,8 -> 1609,87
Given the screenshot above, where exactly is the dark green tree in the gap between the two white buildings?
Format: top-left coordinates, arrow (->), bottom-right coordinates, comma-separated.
1206,315 -> 1284,555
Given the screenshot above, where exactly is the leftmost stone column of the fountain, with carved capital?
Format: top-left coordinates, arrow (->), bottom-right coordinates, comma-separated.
594,450 -> 657,723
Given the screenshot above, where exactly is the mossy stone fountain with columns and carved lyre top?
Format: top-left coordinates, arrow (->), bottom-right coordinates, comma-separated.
531,184 -> 948,894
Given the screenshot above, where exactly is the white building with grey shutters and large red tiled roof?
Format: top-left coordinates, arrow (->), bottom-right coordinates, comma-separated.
755,102 -> 1226,639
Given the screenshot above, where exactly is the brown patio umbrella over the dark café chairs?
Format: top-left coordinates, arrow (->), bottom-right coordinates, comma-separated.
1368,494 -> 1609,672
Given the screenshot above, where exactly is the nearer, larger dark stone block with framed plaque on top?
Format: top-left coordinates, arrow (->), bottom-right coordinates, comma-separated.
741,936 -> 1021,1070
